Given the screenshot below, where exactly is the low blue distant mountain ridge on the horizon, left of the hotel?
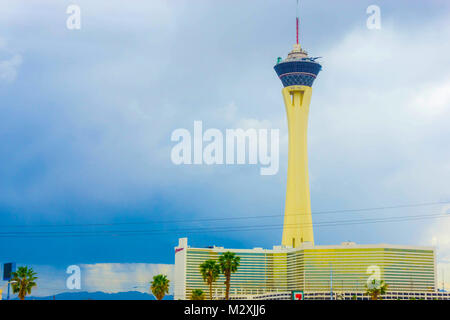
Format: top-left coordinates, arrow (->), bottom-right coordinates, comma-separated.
26,291 -> 173,300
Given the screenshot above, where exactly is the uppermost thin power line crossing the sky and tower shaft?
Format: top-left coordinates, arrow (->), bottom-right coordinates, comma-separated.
0,201 -> 450,228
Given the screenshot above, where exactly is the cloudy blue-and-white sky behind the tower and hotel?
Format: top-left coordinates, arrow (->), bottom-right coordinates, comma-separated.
0,0 -> 450,293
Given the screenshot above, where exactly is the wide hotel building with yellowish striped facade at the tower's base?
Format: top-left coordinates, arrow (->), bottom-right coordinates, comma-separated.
174,238 -> 442,300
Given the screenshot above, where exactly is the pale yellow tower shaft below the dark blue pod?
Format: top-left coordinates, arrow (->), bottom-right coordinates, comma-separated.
282,86 -> 314,248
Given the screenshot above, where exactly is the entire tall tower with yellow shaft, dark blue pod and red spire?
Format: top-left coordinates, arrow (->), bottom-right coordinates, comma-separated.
274,12 -> 322,248
